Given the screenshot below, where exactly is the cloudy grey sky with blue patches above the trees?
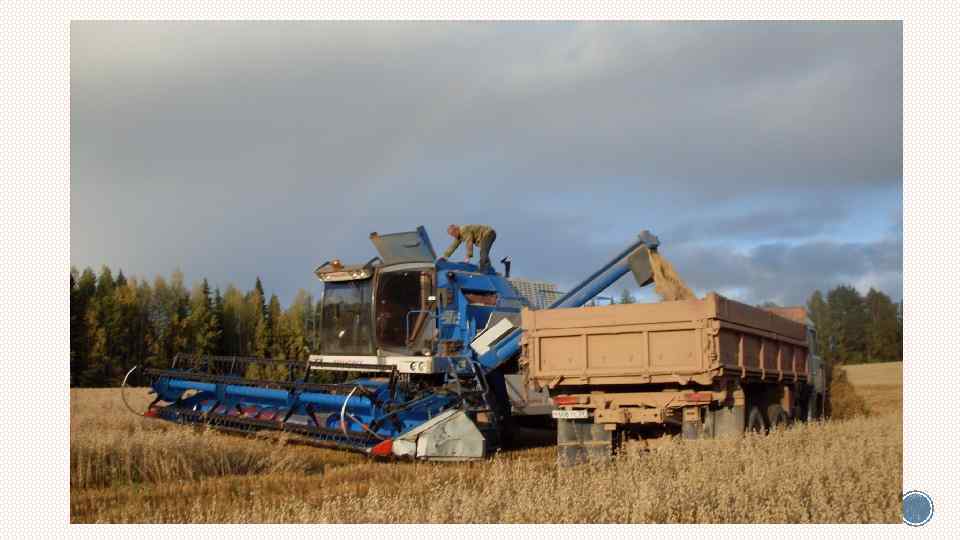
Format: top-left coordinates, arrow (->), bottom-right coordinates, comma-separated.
70,22 -> 903,304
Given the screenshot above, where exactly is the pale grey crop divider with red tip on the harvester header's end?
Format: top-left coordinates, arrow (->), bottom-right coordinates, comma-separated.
370,409 -> 486,461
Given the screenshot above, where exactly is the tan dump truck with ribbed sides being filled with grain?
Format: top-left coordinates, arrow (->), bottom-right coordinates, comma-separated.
521,293 -> 825,465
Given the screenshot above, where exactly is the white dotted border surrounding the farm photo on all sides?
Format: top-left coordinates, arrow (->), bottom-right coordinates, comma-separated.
0,0 -> 948,538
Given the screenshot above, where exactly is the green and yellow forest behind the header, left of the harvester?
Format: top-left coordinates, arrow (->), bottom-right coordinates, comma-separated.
70,266 -> 320,386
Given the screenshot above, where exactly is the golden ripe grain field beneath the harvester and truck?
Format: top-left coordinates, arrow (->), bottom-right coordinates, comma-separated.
70,364 -> 902,523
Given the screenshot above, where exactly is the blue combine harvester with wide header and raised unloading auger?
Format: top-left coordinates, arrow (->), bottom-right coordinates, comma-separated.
128,227 -> 659,460
